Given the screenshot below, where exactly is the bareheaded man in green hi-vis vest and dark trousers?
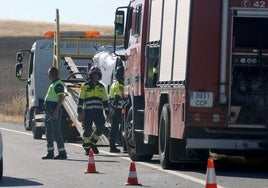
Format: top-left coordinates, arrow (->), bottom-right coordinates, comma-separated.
42,67 -> 67,159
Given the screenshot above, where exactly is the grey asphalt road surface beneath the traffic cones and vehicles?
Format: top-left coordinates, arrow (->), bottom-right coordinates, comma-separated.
0,122 -> 268,188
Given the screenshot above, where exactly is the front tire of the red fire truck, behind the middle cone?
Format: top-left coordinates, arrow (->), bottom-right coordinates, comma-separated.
125,108 -> 153,161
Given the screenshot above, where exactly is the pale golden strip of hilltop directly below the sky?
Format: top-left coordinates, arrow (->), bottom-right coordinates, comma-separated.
0,19 -> 113,37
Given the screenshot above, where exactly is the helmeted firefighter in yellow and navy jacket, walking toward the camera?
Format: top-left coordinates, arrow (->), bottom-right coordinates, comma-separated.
77,66 -> 110,154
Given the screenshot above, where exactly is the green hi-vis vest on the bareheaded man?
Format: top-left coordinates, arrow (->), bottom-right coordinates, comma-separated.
45,79 -> 66,102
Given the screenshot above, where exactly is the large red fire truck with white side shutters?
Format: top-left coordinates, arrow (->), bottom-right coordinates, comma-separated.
115,0 -> 268,168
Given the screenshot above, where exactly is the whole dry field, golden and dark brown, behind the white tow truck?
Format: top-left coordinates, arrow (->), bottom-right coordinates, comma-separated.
0,20 -> 113,123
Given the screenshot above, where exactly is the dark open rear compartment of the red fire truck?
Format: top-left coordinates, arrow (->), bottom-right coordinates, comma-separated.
230,7 -> 268,126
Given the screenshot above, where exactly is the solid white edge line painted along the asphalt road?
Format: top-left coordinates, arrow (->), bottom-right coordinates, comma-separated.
0,127 -> 224,188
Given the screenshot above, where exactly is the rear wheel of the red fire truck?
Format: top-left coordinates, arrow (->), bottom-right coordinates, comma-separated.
158,104 -> 171,169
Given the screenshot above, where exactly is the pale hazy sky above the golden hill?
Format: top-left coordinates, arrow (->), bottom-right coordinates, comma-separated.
0,0 -> 129,25
